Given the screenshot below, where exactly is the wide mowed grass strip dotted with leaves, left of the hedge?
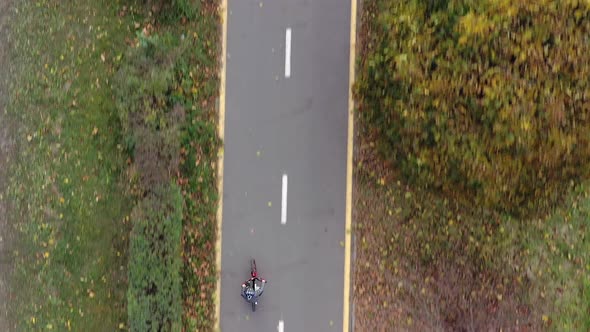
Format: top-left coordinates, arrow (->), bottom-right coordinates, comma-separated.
8,0 -> 137,331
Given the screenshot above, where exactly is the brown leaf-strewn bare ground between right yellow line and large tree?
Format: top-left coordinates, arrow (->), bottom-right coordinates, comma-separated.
353,139 -> 539,331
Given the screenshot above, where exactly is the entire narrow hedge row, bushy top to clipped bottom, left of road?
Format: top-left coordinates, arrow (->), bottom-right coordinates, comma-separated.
114,34 -> 184,331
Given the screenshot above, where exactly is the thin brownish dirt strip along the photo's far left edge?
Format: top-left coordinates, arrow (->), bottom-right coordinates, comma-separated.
0,0 -> 14,331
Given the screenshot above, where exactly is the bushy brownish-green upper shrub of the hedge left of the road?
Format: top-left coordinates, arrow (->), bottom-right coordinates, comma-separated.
114,34 -> 184,192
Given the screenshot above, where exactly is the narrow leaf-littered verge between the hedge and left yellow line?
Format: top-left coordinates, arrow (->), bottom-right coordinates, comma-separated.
178,0 -> 221,331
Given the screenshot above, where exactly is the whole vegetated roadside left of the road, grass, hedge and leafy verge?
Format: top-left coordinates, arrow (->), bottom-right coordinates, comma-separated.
7,0 -> 219,331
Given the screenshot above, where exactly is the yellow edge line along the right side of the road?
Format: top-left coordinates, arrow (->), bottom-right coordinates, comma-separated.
342,0 -> 357,332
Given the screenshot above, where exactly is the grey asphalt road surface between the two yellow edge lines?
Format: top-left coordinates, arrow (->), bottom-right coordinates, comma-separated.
221,0 -> 350,332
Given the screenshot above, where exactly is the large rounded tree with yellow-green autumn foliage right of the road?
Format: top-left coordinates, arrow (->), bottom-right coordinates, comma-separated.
356,0 -> 590,213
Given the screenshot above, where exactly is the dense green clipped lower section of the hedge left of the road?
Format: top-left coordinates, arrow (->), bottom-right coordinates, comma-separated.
127,184 -> 183,332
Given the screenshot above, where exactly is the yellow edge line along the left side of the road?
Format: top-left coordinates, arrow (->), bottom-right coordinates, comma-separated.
214,0 -> 227,331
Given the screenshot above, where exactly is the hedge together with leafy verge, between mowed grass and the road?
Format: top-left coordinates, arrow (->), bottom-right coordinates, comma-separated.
114,1 -> 219,331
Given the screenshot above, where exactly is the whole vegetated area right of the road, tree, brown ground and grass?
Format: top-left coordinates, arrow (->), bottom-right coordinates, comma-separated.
354,0 -> 590,331
